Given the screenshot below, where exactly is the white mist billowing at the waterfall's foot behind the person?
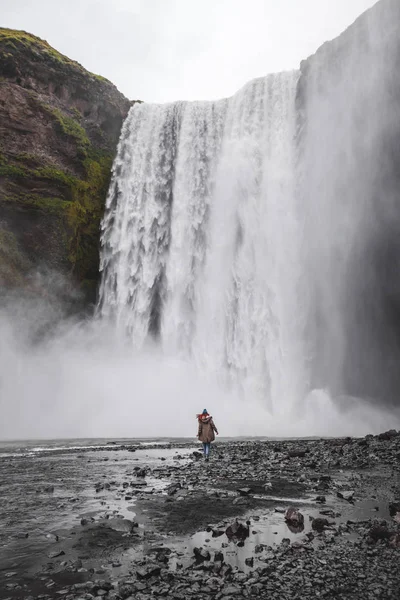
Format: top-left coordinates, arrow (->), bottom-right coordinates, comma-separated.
0,270 -> 398,441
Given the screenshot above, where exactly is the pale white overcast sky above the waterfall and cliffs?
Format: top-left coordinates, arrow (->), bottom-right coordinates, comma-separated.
0,0 -> 376,102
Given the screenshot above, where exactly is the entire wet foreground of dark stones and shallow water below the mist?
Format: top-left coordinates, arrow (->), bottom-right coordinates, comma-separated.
0,432 -> 400,600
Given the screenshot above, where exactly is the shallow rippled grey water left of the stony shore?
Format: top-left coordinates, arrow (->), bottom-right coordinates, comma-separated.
0,440 -> 193,573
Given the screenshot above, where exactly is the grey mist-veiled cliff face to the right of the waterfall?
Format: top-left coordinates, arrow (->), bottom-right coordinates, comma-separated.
297,0 -> 400,403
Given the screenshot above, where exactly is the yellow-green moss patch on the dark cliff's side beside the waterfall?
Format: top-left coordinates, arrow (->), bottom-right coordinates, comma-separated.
0,123 -> 113,287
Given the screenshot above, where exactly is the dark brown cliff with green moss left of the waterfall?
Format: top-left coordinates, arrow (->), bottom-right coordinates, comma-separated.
0,29 -> 132,297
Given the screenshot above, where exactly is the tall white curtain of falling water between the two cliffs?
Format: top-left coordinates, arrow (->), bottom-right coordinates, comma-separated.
99,72 -> 308,411
